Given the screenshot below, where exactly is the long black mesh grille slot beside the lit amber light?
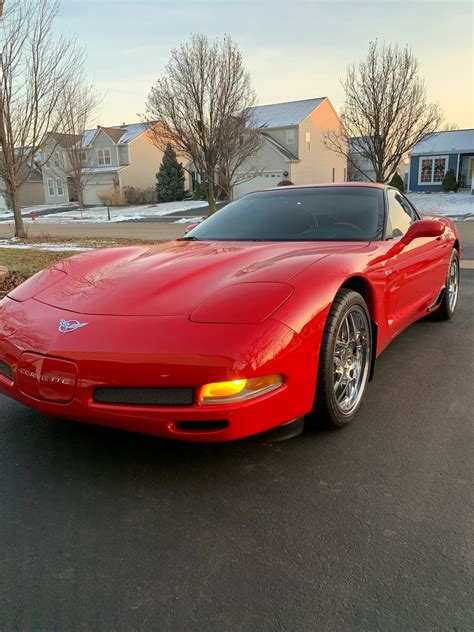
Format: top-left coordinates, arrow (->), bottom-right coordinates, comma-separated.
94,387 -> 194,406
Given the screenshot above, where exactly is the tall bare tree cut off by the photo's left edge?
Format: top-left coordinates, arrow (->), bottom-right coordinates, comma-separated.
0,0 -> 84,237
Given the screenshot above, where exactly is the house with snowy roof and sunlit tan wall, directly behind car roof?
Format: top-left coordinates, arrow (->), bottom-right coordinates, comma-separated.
234,97 -> 347,198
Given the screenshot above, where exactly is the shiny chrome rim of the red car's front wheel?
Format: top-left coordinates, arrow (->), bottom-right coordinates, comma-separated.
333,305 -> 371,415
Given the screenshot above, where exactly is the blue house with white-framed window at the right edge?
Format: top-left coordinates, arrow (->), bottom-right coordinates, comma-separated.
409,129 -> 474,192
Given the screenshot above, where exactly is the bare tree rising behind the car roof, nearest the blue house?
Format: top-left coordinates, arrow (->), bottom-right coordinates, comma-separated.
325,42 -> 443,182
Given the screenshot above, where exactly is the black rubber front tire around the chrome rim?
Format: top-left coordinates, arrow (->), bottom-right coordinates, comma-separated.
310,288 -> 372,428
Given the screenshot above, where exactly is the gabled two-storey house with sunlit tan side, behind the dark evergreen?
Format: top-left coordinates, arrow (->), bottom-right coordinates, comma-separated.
42,123 -> 187,205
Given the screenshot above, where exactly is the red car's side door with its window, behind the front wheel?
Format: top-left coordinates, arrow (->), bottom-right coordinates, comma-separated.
387,189 -> 449,333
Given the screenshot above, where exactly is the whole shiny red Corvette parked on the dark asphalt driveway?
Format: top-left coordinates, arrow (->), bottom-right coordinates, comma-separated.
0,183 -> 460,441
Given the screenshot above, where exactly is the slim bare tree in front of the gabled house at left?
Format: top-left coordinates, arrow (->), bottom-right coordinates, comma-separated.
53,77 -> 100,211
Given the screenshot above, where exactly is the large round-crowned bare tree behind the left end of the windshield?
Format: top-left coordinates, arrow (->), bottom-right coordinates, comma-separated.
146,35 -> 262,213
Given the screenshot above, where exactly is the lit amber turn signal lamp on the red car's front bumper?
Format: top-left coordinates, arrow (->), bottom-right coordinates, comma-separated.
199,375 -> 283,406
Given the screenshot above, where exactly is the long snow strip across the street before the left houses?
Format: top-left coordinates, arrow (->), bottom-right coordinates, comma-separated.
0,200 -> 207,224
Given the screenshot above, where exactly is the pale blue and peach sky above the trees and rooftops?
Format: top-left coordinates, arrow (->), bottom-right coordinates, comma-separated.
56,0 -> 474,128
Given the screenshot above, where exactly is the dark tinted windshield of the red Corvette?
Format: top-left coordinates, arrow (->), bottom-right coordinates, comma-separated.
185,186 -> 384,241
